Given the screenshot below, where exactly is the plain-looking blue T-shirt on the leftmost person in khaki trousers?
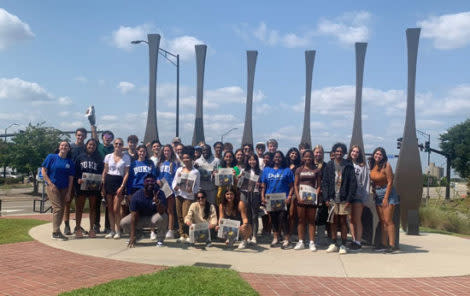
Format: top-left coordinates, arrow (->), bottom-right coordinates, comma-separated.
41,154 -> 75,189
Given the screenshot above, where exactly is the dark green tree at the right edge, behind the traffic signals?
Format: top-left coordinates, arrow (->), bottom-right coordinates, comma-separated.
439,119 -> 470,178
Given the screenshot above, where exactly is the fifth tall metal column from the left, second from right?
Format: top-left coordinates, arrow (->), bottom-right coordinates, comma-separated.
351,42 -> 367,156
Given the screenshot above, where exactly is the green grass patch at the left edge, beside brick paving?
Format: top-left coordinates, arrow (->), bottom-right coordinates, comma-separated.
0,219 -> 48,245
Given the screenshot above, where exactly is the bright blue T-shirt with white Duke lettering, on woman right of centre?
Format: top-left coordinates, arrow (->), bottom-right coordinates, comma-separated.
260,167 -> 294,196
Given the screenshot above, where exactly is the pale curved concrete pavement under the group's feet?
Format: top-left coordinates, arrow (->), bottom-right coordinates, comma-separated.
30,220 -> 470,278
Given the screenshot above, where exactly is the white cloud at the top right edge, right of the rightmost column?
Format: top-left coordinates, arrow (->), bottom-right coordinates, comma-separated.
417,11 -> 470,49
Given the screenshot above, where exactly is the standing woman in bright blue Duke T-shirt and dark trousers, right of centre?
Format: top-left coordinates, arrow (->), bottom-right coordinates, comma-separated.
261,151 -> 294,249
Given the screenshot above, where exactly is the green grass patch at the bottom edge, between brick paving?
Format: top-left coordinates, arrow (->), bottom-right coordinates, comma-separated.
60,266 -> 258,296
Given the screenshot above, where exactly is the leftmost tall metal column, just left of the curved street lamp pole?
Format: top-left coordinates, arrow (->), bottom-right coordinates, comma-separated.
144,34 -> 160,144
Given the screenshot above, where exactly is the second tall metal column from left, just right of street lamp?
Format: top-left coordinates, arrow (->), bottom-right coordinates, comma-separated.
192,44 -> 207,146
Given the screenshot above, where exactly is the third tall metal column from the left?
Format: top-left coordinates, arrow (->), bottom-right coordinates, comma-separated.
242,50 -> 258,146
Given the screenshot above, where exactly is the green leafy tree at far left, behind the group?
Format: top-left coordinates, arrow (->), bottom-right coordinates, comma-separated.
11,123 -> 69,194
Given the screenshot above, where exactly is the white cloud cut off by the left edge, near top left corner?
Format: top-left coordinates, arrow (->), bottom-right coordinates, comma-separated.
0,8 -> 34,50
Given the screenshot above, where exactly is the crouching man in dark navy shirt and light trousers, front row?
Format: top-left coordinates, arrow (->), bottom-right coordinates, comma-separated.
121,174 -> 168,248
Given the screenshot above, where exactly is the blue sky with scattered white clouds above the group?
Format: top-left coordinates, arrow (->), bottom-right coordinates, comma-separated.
0,0 -> 470,168
